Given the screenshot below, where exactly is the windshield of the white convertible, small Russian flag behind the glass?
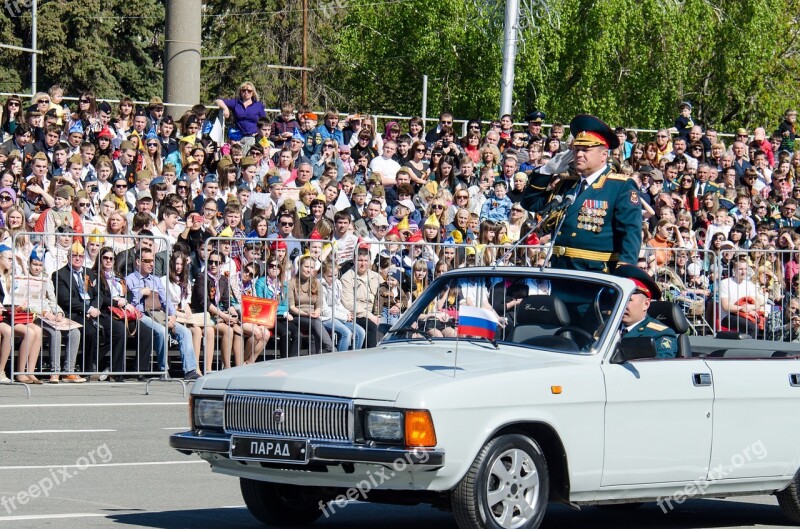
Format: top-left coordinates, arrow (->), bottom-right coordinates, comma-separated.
384,271 -> 621,353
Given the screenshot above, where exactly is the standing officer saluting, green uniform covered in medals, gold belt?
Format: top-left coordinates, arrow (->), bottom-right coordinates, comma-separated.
522,114 -> 642,272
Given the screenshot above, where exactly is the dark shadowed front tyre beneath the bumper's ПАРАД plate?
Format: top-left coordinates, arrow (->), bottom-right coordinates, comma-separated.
239,478 -> 322,526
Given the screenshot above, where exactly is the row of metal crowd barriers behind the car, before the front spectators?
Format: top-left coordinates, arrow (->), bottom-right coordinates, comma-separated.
0,232 -> 800,394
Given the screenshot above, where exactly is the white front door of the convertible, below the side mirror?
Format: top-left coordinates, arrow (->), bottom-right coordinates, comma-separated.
601,358 -> 714,487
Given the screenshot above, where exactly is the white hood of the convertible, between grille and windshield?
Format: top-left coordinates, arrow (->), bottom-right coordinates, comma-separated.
198,341 -> 576,401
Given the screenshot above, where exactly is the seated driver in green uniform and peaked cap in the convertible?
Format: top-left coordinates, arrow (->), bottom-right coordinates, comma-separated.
614,265 -> 678,358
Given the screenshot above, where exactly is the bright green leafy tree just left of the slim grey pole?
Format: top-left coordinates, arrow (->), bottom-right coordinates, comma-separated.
328,0 -> 501,116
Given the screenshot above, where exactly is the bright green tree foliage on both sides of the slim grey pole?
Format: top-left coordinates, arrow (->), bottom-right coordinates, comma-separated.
326,0 -> 800,129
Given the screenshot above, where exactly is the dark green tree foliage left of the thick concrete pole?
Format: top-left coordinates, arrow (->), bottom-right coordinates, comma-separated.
0,0 -> 164,99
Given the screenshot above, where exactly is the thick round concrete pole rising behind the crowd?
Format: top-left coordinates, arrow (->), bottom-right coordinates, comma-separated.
164,0 -> 203,118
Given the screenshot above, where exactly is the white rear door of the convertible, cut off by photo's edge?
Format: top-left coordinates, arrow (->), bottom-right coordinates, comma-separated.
706,358 -> 800,481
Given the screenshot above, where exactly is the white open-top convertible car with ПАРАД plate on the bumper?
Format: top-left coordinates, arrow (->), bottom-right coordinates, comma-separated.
170,267 -> 800,528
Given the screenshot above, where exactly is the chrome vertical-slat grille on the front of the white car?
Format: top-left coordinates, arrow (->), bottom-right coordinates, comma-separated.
225,392 -> 353,441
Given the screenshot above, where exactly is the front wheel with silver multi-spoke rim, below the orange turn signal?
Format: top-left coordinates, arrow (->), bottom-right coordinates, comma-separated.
451,434 -> 550,529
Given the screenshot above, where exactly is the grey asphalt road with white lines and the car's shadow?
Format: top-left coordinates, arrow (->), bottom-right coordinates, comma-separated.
0,382 -> 789,529
